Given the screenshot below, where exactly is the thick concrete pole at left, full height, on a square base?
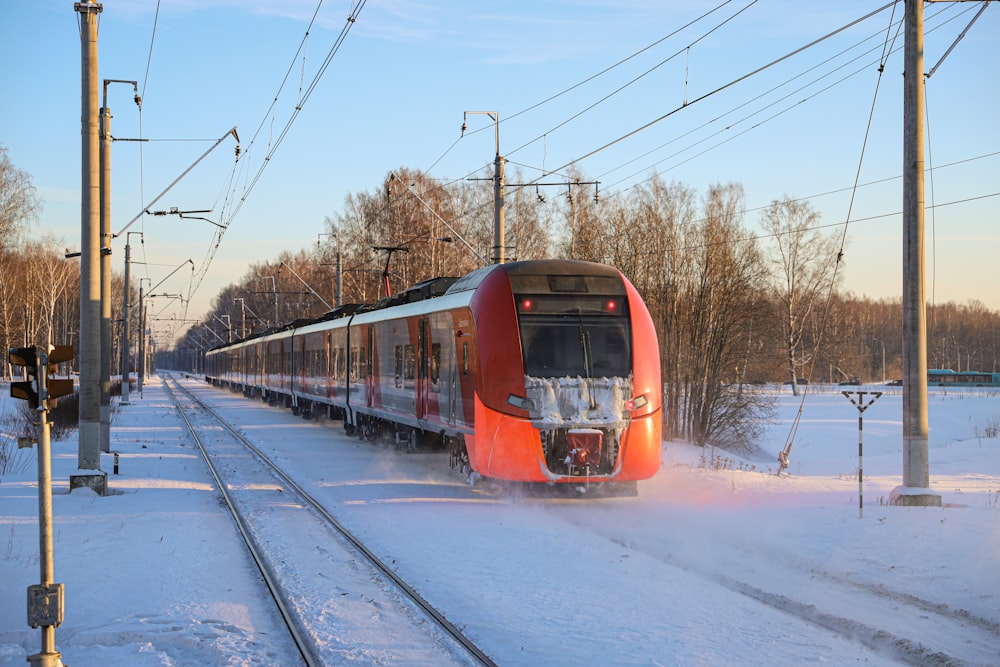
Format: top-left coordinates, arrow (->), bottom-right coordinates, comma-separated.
70,2 -> 108,496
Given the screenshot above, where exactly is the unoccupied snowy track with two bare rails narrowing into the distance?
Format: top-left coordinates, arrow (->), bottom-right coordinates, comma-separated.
164,377 -> 495,667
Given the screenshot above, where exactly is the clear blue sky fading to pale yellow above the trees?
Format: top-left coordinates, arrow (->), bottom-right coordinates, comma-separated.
0,0 -> 1000,340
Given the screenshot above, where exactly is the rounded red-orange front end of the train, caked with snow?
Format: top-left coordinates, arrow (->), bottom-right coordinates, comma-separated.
467,260 -> 661,483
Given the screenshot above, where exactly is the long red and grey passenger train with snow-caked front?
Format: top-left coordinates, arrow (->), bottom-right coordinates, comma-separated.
205,260 -> 661,489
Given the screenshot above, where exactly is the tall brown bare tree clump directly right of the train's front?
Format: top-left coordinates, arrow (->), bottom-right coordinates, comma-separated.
606,177 -> 769,446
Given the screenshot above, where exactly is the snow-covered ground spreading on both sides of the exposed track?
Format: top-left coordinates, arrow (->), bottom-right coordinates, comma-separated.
0,379 -> 1000,667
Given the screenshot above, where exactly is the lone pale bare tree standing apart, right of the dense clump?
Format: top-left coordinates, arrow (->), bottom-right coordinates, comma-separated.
761,196 -> 840,396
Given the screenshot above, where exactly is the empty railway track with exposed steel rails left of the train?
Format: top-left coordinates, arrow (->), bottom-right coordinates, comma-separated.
165,378 -> 495,667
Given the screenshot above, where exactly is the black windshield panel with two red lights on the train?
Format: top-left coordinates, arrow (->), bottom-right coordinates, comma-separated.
517,294 -> 632,378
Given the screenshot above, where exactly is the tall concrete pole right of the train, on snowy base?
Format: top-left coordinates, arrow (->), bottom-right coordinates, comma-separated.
890,0 -> 941,507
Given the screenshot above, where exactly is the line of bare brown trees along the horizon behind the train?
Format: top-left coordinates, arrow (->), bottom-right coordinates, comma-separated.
0,146 -> 1000,446
